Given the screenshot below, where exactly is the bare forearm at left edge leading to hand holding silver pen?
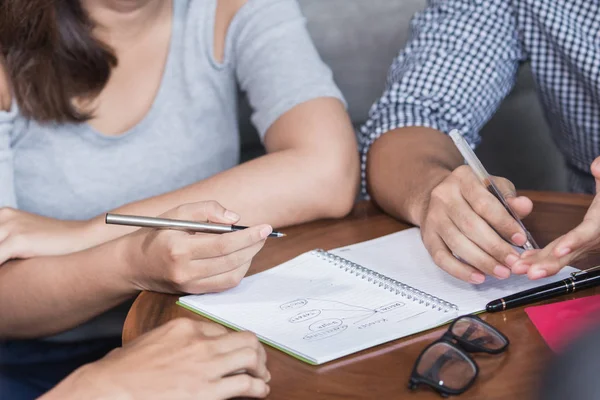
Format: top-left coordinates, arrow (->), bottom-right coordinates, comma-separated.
0,241 -> 136,339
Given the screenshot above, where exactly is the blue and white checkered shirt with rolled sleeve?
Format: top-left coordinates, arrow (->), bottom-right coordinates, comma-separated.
359,0 -> 600,195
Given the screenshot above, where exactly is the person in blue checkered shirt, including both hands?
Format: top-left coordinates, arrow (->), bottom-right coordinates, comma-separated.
359,0 -> 600,284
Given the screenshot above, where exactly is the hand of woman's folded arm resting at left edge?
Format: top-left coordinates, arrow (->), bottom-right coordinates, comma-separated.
0,208 -> 96,265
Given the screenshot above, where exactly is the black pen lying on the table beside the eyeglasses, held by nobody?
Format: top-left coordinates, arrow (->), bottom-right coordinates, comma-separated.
485,265 -> 600,312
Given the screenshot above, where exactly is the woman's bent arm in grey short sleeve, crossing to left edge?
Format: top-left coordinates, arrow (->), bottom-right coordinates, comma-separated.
0,0 -> 359,264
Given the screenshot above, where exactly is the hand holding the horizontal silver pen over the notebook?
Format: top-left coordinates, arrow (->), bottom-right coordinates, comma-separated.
122,201 -> 273,294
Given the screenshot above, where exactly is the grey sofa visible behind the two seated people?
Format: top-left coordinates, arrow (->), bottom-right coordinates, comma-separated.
240,0 -> 566,191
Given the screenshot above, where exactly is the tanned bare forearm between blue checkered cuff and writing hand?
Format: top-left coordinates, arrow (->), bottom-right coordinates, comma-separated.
367,127 -> 462,225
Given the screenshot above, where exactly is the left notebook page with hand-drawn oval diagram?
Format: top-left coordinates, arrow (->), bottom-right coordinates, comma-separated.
180,253 -> 449,363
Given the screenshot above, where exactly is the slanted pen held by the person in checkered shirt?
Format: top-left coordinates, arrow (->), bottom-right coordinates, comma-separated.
450,129 -> 540,250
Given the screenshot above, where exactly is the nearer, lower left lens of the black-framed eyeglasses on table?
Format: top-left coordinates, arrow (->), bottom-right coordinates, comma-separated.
417,342 -> 476,389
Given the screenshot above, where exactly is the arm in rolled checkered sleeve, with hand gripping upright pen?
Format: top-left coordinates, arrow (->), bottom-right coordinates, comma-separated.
360,0 -> 532,283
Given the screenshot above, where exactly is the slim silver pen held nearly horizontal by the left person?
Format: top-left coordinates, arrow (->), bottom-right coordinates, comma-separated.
105,213 -> 286,237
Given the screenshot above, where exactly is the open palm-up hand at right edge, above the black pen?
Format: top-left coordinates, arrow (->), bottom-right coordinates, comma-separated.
514,157 -> 600,279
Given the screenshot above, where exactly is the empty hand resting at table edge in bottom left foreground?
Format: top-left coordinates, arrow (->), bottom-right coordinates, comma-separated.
42,319 -> 271,400
